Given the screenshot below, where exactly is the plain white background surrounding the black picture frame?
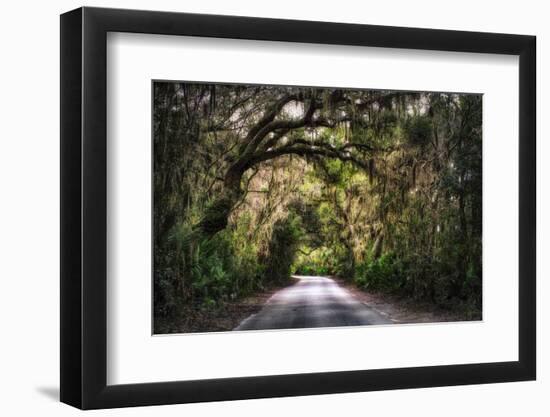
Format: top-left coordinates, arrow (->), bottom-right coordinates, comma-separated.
0,0 -> 550,417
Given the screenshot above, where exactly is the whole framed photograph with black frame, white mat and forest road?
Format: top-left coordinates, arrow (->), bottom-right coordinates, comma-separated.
61,7 -> 536,409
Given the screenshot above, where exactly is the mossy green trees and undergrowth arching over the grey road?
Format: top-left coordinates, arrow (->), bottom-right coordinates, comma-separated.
153,82 -> 482,328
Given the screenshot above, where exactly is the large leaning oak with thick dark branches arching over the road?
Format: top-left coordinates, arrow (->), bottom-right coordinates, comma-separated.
194,86 -> 402,236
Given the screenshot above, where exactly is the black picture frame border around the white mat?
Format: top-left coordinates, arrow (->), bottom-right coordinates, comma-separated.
60,7 -> 536,409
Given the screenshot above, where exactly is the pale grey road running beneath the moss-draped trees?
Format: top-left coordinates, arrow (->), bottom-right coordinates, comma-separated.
234,275 -> 392,330
